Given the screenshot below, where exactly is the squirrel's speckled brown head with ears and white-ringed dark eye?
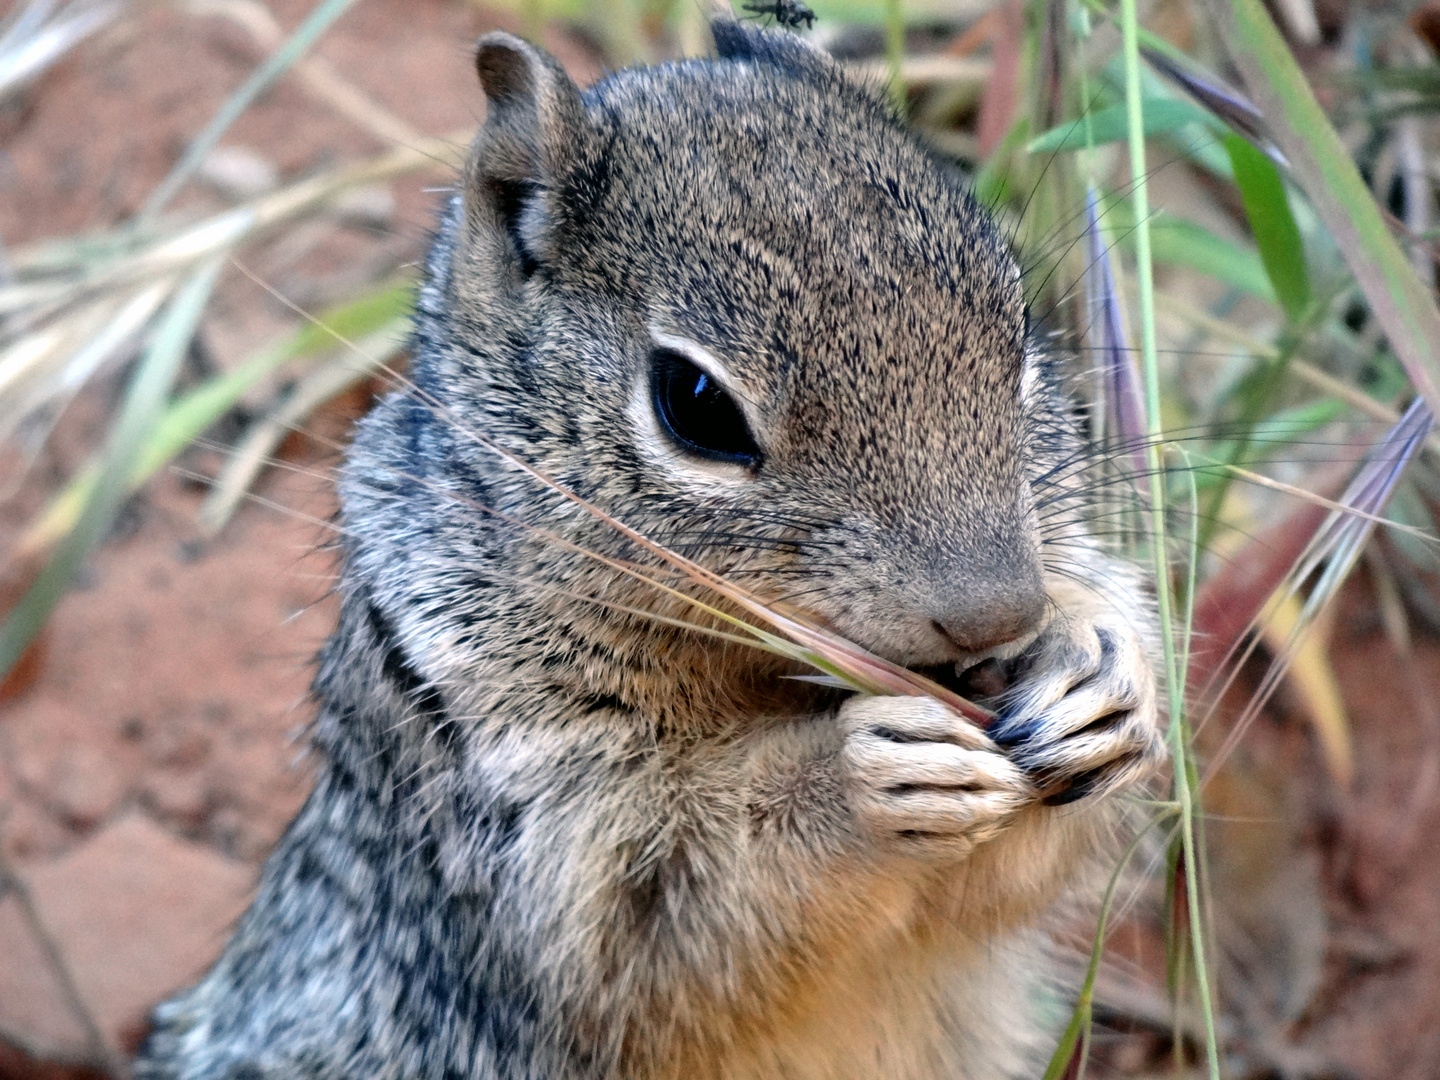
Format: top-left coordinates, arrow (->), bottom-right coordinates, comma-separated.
361,22 -> 1045,720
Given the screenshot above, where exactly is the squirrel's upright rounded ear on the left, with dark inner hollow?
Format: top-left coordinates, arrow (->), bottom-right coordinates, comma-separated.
465,32 -> 586,276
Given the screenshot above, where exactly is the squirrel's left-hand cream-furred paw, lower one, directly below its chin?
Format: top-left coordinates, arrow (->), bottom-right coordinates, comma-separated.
840,697 -> 1035,858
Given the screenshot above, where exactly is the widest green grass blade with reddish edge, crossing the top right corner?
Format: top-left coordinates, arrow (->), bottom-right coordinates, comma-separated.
1210,0 -> 1440,416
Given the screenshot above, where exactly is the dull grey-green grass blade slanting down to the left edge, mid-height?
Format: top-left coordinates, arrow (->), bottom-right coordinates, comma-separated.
0,259 -> 222,678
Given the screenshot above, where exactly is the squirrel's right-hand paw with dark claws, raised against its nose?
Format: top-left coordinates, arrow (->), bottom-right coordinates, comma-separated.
994,619 -> 1165,806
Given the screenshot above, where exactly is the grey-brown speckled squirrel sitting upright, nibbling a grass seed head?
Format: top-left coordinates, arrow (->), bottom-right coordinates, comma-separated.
135,19 -> 1164,1080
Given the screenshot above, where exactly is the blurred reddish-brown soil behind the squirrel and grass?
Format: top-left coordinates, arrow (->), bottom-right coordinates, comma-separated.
0,0 -> 1440,1080
